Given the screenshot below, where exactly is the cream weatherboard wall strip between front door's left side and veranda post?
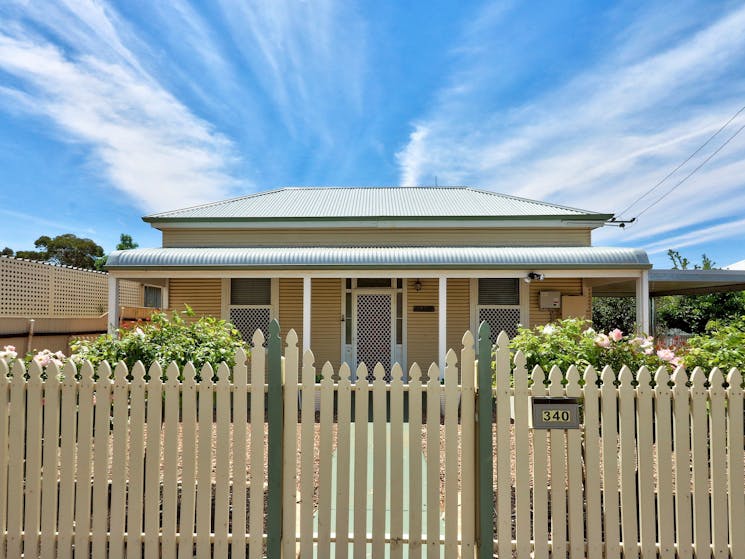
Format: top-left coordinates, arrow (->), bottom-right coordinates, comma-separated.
310,278 -> 343,369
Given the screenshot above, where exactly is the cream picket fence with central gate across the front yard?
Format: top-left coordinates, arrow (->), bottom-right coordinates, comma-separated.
0,326 -> 745,559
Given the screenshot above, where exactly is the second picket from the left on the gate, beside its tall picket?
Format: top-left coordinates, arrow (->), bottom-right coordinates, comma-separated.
300,350 -> 316,557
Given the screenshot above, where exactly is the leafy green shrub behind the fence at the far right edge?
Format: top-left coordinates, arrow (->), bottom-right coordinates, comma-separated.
682,316 -> 745,375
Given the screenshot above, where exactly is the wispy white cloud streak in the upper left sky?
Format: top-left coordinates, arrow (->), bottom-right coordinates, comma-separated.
0,0 -> 236,211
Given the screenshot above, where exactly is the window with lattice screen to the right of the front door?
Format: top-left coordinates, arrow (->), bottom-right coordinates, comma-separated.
478,278 -> 520,343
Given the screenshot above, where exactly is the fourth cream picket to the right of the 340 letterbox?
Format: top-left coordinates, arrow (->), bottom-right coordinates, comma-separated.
636,367 -> 657,557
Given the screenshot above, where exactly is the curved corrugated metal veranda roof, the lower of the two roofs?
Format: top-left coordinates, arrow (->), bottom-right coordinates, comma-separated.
107,247 -> 650,270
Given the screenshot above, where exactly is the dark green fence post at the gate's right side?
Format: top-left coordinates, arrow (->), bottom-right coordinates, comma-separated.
476,322 -> 494,559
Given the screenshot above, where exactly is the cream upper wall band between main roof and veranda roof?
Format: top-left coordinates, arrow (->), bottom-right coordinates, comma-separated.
163,228 -> 591,247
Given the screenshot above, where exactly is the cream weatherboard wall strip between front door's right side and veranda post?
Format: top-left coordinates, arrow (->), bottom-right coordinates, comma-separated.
406,278 -> 438,370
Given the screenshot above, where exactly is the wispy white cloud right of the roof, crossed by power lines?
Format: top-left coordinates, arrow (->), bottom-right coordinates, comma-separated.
398,2 -> 745,254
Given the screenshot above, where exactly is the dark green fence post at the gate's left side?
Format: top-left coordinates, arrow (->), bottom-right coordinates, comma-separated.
266,320 -> 284,557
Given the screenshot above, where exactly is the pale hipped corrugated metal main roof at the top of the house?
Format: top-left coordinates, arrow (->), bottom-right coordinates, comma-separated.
144,187 -> 610,222
